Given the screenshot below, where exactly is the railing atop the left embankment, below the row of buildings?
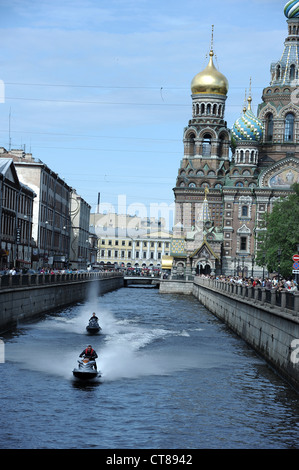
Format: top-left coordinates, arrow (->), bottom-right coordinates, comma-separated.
0,271 -> 123,291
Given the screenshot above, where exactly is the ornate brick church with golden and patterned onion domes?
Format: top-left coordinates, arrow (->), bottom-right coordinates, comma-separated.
170,1 -> 299,277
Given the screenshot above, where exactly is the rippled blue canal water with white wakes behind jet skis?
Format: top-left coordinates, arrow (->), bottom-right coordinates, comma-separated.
0,287 -> 299,449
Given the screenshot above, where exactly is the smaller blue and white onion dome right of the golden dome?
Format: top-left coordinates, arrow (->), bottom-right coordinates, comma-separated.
231,99 -> 263,146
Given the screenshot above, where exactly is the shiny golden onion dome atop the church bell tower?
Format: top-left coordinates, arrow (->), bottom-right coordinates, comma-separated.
191,50 -> 229,95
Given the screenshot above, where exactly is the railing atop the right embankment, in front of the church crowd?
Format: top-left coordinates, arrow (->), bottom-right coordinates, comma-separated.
194,277 -> 299,313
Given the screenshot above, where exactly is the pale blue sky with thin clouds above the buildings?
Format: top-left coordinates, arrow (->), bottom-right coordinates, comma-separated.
0,0 -> 287,228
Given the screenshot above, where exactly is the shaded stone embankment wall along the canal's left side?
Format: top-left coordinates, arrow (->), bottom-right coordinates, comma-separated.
0,273 -> 124,332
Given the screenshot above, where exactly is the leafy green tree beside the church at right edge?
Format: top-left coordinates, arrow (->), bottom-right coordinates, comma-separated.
256,183 -> 299,277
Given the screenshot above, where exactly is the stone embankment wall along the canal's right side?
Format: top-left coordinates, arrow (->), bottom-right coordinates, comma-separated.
160,278 -> 299,391
